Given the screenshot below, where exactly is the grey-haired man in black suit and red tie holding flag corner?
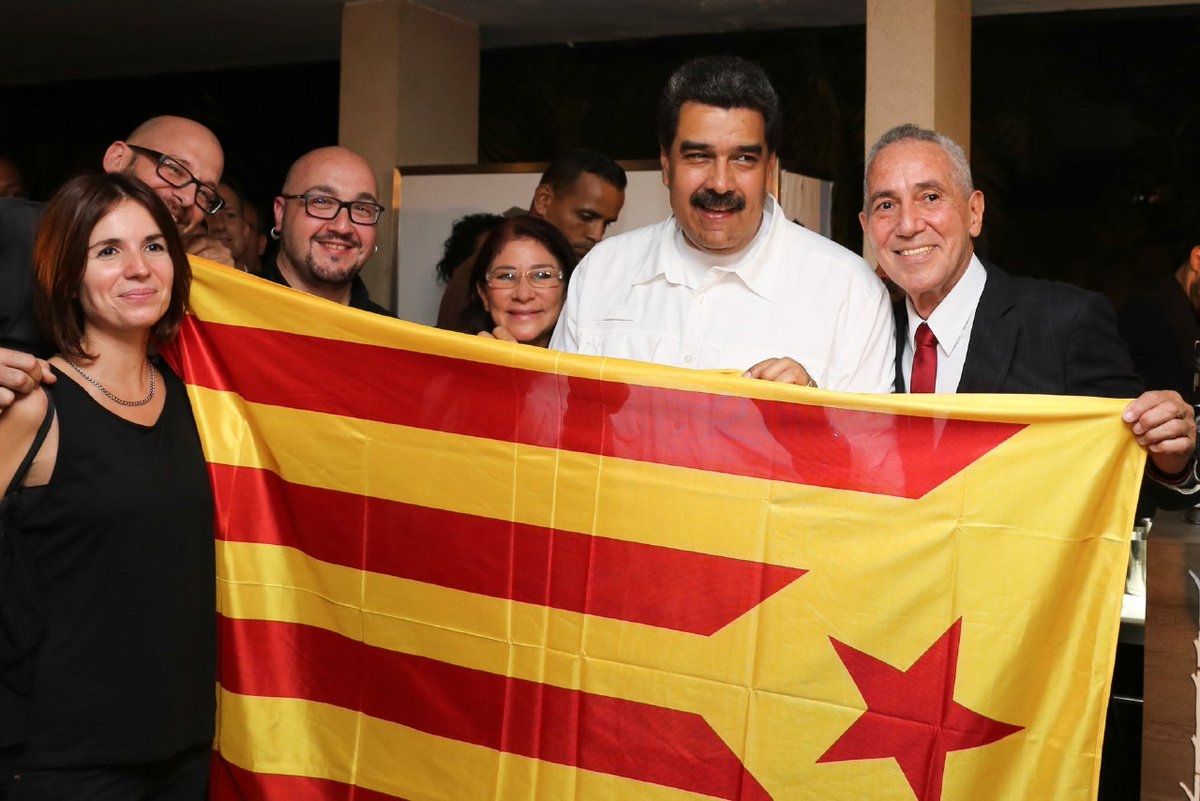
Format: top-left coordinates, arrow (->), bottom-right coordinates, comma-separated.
859,125 -> 1200,484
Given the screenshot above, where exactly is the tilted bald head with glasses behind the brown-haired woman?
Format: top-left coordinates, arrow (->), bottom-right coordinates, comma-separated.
103,116 -> 224,233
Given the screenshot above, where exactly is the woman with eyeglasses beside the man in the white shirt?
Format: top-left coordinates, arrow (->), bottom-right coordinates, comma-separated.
458,215 -> 576,348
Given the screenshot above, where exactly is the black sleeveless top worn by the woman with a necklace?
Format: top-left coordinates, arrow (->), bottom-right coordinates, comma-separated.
11,360 -> 216,767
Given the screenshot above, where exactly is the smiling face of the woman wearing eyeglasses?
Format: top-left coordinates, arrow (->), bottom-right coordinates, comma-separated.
476,239 -> 565,348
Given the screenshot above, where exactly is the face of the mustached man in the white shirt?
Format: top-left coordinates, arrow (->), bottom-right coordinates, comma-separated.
660,102 -> 775,255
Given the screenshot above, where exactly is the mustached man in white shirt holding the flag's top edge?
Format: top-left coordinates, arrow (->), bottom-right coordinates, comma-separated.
550,56 -> 894,392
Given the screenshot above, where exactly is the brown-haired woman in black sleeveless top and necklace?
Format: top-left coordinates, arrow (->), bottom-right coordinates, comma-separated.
0,173 -> 216,801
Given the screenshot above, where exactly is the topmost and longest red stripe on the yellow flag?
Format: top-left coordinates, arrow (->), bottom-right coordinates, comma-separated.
173,318 -> 1024,498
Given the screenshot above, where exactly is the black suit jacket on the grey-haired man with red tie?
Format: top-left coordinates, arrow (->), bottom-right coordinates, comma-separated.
895,261 -> 1142,398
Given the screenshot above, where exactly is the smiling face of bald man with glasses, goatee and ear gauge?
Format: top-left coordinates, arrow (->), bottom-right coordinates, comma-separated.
275,147 -> 379,297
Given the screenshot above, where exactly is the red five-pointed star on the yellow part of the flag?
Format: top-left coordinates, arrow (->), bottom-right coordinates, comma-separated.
817,618 -> 1022,801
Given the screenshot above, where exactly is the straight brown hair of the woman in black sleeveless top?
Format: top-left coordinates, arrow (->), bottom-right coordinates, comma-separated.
34,173 -> 192,359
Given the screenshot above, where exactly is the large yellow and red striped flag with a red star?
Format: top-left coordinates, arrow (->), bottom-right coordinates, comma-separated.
172,263 -> 1144,801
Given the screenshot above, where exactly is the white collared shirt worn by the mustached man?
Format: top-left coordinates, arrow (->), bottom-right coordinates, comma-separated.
550,197 -> 895,392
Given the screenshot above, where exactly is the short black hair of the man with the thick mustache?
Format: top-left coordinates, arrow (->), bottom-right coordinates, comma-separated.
659,55 -> 780,152
